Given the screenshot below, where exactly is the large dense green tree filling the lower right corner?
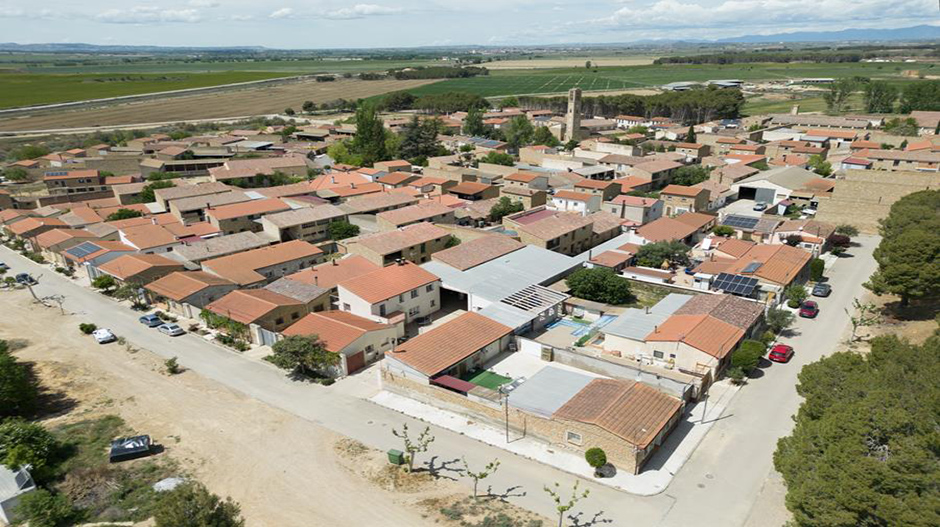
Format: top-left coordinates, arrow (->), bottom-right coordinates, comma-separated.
773,335 -> 940,527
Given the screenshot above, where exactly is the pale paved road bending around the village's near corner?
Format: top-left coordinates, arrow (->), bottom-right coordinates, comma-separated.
0,237 -> 877,526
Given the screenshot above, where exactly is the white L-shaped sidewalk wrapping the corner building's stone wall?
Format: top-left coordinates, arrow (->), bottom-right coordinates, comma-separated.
369,382 -> 738,496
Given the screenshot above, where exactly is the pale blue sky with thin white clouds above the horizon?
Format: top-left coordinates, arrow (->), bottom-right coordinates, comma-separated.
0,0 -> 940,49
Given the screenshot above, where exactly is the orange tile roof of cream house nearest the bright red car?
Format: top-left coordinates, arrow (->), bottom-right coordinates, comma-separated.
646,314 -> 744,360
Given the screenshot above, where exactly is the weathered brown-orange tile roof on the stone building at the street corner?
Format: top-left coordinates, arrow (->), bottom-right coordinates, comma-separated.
553,379 -> 682,448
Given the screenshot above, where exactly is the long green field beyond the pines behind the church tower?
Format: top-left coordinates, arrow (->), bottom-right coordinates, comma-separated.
410,63 -> 924,97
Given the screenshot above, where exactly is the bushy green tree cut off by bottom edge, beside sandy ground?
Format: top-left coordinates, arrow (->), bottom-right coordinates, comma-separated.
153,482 -> 245,527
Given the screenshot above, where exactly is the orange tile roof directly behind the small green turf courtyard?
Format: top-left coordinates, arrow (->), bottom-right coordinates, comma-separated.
385,313 -> 512,377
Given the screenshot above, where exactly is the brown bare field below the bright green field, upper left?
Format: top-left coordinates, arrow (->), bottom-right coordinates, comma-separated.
0,79 -> 436,131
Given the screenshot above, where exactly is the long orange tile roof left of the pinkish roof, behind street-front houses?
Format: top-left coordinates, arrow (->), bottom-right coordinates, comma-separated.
202,240 -> 323,285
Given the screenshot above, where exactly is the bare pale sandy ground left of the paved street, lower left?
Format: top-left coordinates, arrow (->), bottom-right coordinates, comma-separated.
0,291 -> 464,527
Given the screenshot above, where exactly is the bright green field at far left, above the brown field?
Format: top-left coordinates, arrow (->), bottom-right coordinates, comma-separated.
0,71 -> 296,108
